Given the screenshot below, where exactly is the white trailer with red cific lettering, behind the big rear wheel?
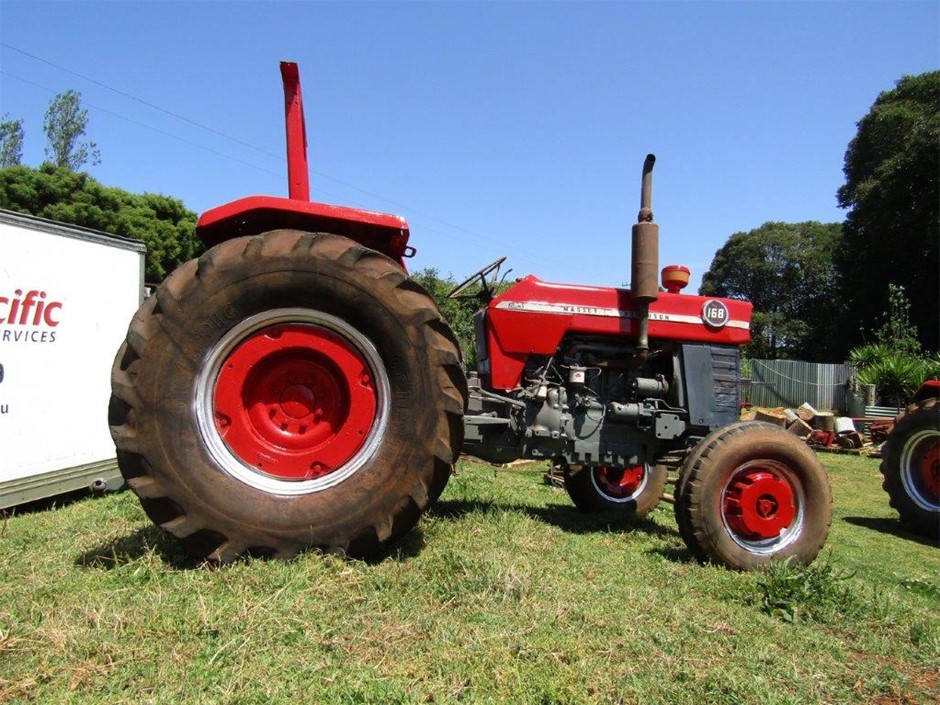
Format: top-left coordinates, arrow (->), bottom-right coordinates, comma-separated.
0,210 -> 145,509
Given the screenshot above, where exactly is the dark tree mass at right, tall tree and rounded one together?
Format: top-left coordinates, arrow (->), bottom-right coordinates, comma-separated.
700,71 -> 940,364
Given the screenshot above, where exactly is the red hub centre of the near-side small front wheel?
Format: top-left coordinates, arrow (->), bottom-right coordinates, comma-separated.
722,465 -> 798,541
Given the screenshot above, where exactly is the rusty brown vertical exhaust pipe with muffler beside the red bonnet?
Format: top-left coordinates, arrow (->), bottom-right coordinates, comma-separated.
630,154 -> 659,364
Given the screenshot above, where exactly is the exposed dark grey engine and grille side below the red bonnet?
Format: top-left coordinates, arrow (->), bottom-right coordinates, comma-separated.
464,333 -> 739,468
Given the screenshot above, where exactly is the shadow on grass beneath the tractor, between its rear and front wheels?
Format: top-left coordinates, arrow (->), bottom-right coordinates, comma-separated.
431,500 -> 678,538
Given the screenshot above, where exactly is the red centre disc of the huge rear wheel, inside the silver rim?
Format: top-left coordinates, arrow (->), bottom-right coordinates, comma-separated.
213,323 -> 378,480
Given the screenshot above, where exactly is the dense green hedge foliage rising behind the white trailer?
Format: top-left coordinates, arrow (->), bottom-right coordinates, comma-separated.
0,164 -> 201,282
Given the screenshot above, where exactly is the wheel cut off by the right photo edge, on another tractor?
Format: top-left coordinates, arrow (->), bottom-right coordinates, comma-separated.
881,399 -> 940,539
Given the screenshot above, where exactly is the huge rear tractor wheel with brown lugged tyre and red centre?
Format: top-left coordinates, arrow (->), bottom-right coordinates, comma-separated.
109,230 -> 467,561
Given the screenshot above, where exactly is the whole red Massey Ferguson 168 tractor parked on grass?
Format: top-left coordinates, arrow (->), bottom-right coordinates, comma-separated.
109,63 -> 832,569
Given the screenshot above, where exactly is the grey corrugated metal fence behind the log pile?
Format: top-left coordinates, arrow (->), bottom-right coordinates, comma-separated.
741,360 -> 853,411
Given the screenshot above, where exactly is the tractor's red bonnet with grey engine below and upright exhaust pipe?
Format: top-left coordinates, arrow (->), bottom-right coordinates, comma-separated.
464,155 -> 751,470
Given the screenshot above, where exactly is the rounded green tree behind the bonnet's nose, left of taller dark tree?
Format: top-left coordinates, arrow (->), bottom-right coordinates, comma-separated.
699,221 -> 844,361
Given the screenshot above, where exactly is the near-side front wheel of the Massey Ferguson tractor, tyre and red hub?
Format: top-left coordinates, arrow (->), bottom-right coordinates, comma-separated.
675,422 -> 832,570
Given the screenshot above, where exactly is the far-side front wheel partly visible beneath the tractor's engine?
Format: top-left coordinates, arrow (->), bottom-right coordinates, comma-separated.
565,465 -> 667,517
